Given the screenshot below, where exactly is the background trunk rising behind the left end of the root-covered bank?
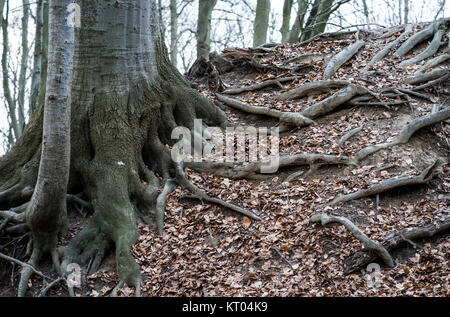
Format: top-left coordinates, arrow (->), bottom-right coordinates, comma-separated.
197,0 -> 217,60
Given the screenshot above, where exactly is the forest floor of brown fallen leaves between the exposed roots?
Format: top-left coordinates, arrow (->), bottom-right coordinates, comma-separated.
0,24 -> 450,297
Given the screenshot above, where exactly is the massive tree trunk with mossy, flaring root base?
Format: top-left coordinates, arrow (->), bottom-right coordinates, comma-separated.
0,0 -> 226,294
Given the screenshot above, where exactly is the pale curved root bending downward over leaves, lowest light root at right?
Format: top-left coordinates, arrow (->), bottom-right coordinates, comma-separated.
311,214 -> 394,267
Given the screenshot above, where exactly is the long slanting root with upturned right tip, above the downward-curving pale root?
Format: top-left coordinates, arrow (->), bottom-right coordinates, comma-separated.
327,161 -> 438,206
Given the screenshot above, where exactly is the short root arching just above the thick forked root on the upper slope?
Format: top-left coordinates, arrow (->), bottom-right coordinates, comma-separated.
277,80 -> 350,100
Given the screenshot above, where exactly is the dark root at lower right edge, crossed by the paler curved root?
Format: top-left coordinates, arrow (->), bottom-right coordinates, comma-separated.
344,215 -> 450,274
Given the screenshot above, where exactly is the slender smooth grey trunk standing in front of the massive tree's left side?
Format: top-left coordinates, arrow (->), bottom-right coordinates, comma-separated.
19,0 -> 74,296
